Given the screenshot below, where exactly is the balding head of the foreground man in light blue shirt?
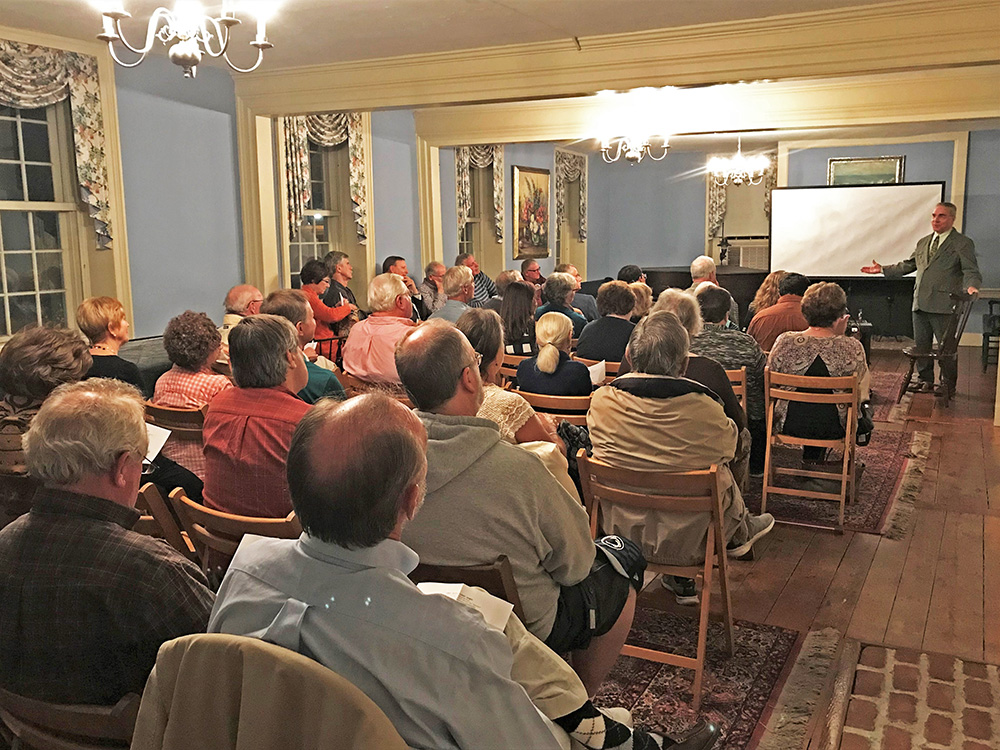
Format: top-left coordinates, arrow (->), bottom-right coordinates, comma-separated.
287,393 -> 427,549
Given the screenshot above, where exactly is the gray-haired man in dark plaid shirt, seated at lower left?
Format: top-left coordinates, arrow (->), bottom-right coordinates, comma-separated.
0,379 -> 214,705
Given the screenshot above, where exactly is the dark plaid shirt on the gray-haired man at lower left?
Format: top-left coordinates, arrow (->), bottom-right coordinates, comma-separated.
0,487 -> 215,705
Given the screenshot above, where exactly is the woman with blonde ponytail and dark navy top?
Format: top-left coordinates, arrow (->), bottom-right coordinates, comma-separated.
517,312 -> 593,396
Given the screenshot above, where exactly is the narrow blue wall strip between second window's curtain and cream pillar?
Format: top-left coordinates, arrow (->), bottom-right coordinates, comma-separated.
372,110 -> 423,274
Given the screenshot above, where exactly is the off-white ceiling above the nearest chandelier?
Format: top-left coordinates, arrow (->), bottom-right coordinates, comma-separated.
0,0 -> 884,70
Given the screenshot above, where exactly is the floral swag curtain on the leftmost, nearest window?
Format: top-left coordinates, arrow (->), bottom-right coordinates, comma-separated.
0,39 -> 112,248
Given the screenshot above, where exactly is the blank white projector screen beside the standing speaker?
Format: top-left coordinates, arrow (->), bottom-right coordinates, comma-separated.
771,182 -> 944,277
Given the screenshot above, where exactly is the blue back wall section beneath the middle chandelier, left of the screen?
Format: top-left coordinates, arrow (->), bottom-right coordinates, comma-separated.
587,152 -> 706,279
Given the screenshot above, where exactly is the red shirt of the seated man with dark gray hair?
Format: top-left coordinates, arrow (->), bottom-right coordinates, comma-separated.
204,386 -> 309,518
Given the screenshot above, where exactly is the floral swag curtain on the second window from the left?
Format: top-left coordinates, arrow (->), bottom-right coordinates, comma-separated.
282,112 -> 368,244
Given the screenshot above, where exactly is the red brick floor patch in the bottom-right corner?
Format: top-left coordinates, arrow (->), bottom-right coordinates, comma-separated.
840,646 -> 1000,750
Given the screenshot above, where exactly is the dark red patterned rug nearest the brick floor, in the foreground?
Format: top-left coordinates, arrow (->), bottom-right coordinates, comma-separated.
595,607 -> 800,750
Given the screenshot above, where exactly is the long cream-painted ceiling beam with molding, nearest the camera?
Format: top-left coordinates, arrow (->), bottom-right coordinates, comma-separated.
236,0 -> 1000,115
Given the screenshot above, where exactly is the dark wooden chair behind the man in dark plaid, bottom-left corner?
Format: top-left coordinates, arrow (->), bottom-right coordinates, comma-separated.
0,689 -> 139,750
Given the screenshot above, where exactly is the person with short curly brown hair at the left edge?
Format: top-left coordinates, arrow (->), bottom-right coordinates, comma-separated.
0,326 -> 91,475
